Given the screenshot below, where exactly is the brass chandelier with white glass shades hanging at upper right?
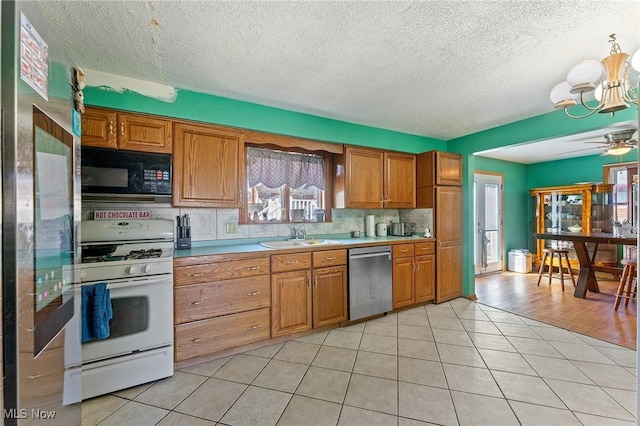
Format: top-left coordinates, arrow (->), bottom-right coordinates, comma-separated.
549,34 -> 640,118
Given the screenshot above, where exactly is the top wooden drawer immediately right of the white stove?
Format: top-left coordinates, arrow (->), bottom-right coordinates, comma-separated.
173,257 -> 269,286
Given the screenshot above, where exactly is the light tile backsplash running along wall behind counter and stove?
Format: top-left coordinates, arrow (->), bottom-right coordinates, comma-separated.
82,202 -> 433,242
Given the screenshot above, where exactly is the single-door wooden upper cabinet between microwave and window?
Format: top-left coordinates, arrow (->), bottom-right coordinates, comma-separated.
172,123 -> 244,208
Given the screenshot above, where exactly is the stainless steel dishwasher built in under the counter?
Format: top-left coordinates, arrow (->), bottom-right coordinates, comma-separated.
349,246 -> 393,321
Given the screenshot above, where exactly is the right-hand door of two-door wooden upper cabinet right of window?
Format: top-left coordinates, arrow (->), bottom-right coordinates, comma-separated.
384,152 -> 416,208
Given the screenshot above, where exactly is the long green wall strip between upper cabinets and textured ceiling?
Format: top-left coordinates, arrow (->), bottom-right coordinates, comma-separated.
84,87 -> 447,154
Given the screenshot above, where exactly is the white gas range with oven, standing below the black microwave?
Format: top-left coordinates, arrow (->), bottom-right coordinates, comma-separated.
76,219 -> 174,399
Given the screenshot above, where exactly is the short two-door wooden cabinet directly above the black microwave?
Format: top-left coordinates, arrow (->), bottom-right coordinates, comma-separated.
82,107 -> 173,154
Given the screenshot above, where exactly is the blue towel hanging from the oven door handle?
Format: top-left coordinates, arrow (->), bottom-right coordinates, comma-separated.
82,283 -> 113,343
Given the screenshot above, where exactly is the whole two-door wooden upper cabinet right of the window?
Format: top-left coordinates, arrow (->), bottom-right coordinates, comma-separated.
334,146 -> 416,209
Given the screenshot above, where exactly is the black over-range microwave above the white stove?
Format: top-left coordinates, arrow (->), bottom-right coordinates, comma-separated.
81,146 -> 171,196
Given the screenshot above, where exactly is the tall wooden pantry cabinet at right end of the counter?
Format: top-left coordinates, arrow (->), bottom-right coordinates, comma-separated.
416,151 -> 463,303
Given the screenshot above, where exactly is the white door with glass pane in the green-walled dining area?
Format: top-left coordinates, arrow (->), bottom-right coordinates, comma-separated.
474,173 -> 504,275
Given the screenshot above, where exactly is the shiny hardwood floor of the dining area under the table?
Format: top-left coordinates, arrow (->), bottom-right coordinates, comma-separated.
476,272 -> 637,349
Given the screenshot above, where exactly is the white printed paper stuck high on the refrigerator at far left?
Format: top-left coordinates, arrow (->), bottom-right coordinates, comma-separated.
20,12 -> 49,101
